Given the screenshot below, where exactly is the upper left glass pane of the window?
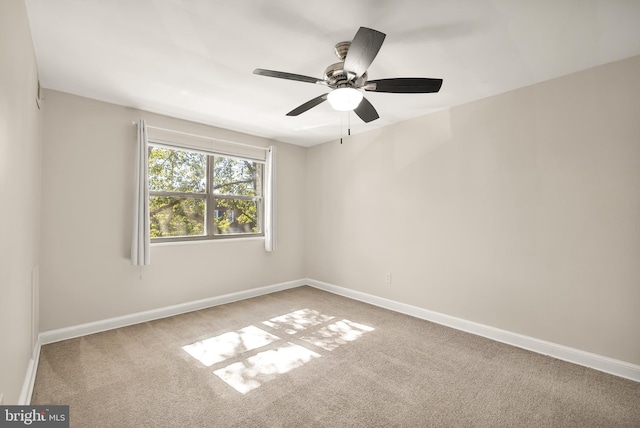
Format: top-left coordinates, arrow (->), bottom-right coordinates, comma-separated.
149,147 -> 207,193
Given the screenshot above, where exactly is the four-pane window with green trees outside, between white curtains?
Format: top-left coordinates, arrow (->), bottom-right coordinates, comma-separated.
148,141 -> 264,242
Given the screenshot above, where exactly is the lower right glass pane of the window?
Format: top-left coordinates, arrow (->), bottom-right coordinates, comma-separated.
214,199 -> 260,235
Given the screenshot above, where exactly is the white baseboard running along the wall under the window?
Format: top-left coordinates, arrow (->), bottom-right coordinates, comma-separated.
39,280 -> 306,345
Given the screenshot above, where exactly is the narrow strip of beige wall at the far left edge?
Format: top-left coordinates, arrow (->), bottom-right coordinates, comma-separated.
0,0 -> 41,404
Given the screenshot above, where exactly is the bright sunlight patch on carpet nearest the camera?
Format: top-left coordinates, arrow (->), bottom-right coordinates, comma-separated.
213,343 -> 320,394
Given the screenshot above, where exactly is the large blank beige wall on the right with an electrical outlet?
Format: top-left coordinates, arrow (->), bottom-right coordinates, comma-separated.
307,57 -> 640,364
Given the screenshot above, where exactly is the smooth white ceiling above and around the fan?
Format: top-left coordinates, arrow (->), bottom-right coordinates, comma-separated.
26,0 -> 640,146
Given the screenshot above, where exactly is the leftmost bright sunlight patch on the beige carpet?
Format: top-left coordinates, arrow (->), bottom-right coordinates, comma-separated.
182,325 -> 280,367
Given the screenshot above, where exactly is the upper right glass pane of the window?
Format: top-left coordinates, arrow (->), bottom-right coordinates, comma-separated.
213,156 -> 262,196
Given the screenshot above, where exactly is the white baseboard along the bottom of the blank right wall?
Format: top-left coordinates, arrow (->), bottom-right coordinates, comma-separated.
305,279 -> 640,382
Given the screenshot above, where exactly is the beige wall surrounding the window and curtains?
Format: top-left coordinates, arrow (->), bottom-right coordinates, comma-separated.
40,91 -> 306,331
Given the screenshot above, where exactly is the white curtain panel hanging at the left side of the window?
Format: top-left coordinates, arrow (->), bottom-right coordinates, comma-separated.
131,119 -> 151,266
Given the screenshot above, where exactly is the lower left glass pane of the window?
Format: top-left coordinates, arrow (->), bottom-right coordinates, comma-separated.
149,196 -> 205,238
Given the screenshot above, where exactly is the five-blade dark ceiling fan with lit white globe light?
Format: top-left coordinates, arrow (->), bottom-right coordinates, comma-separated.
253,27 -> 442,123
